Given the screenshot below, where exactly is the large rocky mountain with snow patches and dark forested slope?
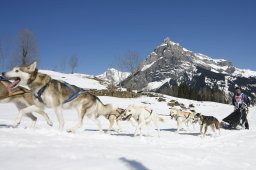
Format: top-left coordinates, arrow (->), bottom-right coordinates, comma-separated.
121,38 -> 256,102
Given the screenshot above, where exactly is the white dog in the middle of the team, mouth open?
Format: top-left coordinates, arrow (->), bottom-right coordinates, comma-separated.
123,106 -> 163,137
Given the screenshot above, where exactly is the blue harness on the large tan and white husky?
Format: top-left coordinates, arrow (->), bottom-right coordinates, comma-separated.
35,81 -> 84,104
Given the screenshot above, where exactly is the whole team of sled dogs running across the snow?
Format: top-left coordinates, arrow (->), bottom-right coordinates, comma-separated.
0,62 -> 220,137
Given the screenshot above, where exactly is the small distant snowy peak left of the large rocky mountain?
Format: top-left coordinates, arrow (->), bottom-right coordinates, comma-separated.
97,68 -> 130,84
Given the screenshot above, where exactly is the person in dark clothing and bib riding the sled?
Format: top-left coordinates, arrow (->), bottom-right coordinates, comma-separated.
222,86 -> 250,129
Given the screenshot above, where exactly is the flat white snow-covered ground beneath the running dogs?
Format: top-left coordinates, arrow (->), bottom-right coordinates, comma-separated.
0,97 -> 256,170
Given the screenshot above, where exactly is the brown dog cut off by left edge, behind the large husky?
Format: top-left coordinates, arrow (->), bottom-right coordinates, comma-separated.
0,79 -> 53,127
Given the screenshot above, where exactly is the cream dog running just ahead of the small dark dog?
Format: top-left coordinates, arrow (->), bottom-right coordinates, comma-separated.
170,107 -> 194,133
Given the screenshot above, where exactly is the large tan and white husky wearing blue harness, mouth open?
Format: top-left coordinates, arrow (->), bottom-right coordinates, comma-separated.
3,62 -> 112,132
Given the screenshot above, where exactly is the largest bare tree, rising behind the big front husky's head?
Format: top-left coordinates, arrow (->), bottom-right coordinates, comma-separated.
14,29 -> 39,65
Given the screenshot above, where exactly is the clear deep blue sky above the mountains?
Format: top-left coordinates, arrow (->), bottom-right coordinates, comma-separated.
0,0 -> 256,74
